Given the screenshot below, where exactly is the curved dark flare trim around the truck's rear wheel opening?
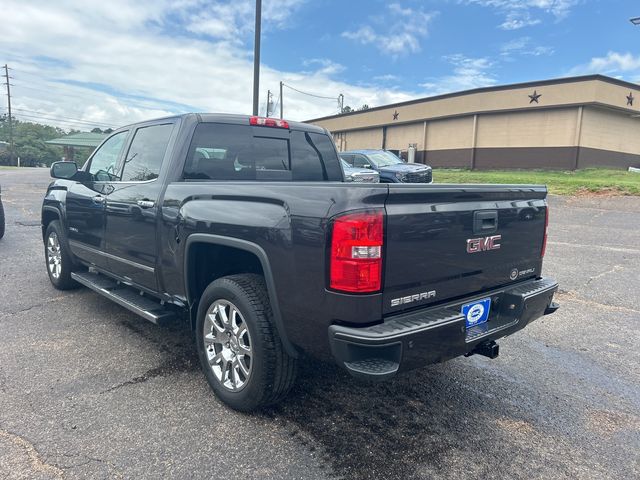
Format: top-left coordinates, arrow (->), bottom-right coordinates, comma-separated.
183,233 -> 299,358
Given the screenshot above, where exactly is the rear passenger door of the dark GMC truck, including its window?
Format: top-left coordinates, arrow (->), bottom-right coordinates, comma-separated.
105,123 -> 175,291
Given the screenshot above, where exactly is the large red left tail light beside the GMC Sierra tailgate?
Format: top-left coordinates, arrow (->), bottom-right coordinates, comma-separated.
329,210 -> 384,293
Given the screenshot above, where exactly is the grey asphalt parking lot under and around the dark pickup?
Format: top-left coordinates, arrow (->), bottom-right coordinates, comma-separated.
0,169 -> 640,479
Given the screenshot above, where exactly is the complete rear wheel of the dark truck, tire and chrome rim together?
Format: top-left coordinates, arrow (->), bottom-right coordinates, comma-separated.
196,274 -> 296,412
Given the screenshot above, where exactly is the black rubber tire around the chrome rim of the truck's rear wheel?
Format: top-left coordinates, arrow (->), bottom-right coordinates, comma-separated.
196,274 -> 297,412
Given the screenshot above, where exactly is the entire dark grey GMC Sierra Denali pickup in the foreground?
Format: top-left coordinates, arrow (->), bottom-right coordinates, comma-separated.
42,114 -> 558,411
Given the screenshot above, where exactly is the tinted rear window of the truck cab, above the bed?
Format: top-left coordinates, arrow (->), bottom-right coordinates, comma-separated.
184,123 -> 342,181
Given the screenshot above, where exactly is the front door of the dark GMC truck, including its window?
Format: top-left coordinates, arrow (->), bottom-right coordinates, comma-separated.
66,131 -> 128,268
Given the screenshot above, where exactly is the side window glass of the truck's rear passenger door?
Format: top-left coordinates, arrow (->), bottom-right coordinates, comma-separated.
122,124 -> 173,182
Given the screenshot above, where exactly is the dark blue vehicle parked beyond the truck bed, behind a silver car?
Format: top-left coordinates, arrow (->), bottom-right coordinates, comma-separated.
340,150 -> 433,183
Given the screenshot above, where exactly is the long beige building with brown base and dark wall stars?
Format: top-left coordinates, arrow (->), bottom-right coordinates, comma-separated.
308,75 -> 640,170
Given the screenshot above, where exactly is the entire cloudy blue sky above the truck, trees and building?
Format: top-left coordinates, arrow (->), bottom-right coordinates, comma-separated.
0,0 -> 640,128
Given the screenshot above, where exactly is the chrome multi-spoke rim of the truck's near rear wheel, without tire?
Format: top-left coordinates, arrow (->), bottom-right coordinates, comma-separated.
203,300 -> 253,392
